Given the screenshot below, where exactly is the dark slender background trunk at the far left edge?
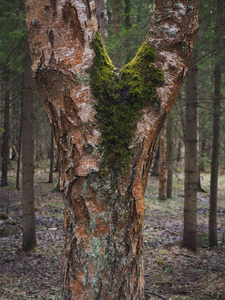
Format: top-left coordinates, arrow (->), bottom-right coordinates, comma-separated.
1,68 -> 11,186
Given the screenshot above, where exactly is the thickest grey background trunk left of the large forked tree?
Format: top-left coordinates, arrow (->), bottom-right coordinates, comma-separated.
22,35 -> 36,251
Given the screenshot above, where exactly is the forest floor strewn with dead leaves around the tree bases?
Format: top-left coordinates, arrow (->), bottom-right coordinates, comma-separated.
0,164 -> 225,300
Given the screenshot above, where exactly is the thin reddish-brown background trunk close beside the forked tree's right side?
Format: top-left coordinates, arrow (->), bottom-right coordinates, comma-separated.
159,122 -> 167,200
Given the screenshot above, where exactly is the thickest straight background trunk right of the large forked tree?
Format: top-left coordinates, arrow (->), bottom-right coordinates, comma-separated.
183,50 -> 198,251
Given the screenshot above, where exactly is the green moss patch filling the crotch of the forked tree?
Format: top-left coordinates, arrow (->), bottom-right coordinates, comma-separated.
91,32 -> 163,172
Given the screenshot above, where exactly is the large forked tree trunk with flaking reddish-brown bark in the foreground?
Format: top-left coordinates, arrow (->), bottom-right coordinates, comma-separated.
26,0 -> 198,300
